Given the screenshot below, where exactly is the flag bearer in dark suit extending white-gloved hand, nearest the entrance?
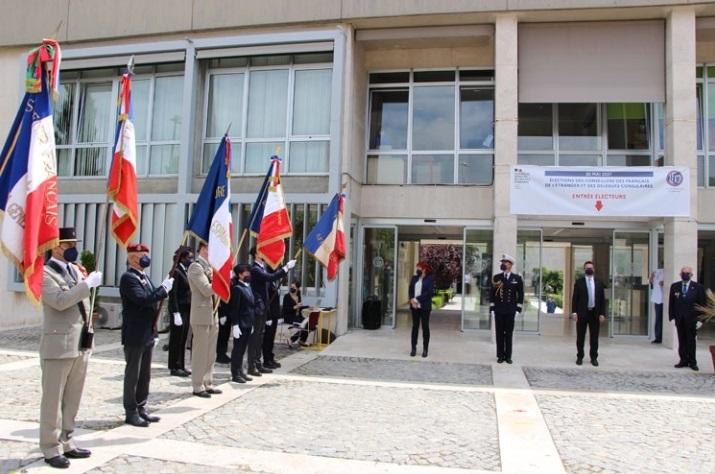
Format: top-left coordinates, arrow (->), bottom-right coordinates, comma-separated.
248,248 -> 295,377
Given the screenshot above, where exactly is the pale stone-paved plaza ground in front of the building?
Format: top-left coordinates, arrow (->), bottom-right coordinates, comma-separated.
0,328 -> 715,474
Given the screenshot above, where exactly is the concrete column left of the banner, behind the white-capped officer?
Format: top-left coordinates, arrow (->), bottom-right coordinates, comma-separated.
493,14 -> 522,272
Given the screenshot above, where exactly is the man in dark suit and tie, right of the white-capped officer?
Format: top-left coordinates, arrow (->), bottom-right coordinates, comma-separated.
571,261 -> 606,367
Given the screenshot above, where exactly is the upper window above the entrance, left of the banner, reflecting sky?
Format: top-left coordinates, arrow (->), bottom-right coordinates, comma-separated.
366,70 -> 494,185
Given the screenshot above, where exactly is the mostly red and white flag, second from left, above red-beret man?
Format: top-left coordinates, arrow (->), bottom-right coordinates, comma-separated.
107,72 -> 139,248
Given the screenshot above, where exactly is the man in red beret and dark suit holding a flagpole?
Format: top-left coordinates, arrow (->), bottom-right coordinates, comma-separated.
119,244 -> 174,427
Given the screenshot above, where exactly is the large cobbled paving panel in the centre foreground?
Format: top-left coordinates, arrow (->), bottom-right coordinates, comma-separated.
163,381 -> 500,471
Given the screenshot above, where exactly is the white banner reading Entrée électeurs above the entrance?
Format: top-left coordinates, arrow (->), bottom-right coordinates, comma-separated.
511,165 -> 690,217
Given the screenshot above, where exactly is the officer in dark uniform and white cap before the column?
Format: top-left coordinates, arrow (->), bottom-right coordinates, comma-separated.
489,254 -> 524,364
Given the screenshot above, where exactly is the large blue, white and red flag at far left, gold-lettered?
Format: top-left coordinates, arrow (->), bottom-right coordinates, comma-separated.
0,40 -> 60,303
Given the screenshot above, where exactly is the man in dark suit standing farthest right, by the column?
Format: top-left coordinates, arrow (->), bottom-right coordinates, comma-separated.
668,267 -> 707,371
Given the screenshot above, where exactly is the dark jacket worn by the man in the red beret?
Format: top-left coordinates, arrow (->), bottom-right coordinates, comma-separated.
119,268 -> 167,347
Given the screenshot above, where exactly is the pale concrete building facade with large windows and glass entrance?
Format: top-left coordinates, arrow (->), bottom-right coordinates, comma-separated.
0,0 -> 715,348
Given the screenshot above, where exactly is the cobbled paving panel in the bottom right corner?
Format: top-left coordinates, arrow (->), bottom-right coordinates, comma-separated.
536,395 -> 715,474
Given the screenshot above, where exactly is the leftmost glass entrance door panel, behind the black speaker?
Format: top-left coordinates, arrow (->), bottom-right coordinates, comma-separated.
360,226 -> 397,328
